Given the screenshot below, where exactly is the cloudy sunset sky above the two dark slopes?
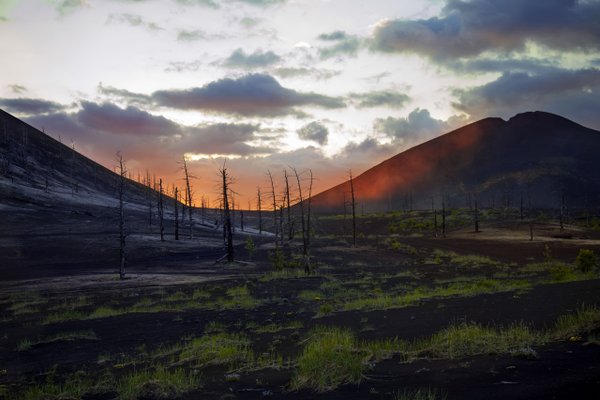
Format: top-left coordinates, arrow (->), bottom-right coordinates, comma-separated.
0,0 -> 600,206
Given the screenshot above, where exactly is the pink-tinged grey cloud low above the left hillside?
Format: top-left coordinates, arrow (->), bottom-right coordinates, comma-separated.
26,102 -> 273,169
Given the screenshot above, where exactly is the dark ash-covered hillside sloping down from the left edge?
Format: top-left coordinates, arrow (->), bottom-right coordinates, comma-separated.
0,110 -> 155,208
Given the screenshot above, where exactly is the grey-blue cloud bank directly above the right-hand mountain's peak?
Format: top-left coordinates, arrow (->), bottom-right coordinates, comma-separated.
453,68 -> 600,128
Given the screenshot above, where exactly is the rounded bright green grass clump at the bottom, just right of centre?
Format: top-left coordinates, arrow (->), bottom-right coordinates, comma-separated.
291,327 -> 366,392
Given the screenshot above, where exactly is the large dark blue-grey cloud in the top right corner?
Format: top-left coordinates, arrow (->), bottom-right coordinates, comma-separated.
371,0 -> 600,61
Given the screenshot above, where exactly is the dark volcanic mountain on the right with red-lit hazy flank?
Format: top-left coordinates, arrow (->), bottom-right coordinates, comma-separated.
313,112 -> 600,212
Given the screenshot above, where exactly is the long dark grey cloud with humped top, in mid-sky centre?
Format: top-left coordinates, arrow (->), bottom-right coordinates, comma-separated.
152,74 -> 345,117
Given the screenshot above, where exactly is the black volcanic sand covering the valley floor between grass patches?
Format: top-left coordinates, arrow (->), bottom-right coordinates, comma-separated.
0,211 -> 600,399
